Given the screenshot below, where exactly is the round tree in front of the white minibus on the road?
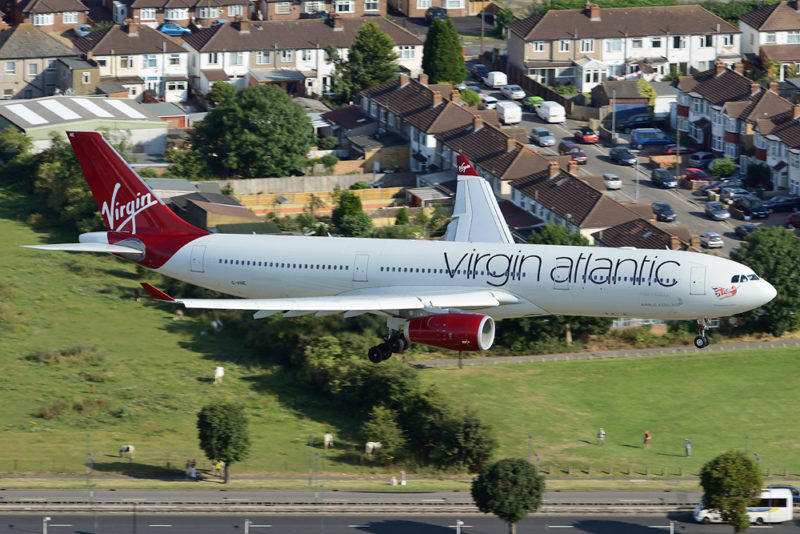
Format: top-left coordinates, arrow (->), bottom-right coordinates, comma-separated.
700,451 -> 761,532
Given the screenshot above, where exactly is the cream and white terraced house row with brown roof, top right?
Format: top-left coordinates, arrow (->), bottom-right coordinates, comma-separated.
507,2 -> 741,92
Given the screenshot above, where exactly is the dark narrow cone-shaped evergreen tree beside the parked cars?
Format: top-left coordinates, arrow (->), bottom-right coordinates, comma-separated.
422,17 -> 467,84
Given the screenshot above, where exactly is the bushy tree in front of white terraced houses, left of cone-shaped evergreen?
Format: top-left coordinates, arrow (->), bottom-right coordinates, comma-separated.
326,22 -> 397,102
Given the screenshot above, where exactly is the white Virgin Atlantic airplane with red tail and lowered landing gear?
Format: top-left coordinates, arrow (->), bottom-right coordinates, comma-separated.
30,132 -> 776,363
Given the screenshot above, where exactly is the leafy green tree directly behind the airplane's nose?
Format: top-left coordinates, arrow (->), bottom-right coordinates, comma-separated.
731,226 -> 800,336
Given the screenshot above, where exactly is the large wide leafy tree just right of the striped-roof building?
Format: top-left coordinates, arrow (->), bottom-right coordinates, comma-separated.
192,85 -> 315,178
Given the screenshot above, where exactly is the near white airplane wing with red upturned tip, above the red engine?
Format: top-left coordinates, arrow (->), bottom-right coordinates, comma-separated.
142,283 -> 519,319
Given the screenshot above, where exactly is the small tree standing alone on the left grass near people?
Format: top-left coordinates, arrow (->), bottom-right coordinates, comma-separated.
197,402 -> 250,484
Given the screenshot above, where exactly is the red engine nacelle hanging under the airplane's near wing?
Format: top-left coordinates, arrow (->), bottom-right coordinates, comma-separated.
405,313 -> 494,350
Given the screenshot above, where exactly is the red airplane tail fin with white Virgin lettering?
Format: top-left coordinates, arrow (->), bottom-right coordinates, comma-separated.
67,132 -> 207,236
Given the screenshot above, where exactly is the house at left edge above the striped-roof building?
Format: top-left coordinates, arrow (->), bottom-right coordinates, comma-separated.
0,23 -> 76,100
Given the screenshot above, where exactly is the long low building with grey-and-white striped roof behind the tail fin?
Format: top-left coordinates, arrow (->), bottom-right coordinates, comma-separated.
0,96 -> 167,156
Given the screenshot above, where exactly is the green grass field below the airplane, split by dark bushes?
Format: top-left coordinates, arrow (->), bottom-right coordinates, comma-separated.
0,192 -> 800,494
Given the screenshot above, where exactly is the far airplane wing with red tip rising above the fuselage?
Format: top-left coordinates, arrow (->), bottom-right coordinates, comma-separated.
442,156 -> 514,244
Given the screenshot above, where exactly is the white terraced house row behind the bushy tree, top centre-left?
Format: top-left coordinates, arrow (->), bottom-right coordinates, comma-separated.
183,17 -> 422,96
